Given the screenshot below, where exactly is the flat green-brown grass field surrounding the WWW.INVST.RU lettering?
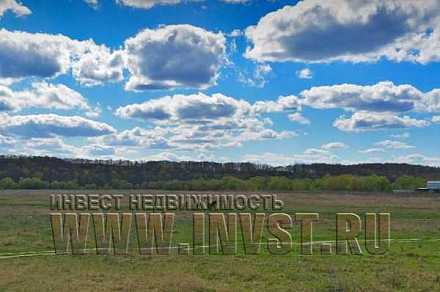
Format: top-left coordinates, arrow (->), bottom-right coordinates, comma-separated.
0,191 -> 440,291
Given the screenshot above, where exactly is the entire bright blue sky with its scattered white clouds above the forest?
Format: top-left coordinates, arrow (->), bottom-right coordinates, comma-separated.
0,0 -> 440,166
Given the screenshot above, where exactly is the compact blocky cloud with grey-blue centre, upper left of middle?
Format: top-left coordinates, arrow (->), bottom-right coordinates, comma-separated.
125,25 -> 226,90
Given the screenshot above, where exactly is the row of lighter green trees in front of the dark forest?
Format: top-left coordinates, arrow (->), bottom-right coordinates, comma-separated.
0,175 -> 426,192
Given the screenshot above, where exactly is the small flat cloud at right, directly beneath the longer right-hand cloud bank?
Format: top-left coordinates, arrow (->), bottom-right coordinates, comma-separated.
333,111 -> 430,132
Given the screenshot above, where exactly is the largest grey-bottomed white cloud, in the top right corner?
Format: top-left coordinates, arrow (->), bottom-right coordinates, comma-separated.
246,0 -> 440,63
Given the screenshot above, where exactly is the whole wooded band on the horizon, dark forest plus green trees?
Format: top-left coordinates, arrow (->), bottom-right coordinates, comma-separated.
0,156 -> 440,191
